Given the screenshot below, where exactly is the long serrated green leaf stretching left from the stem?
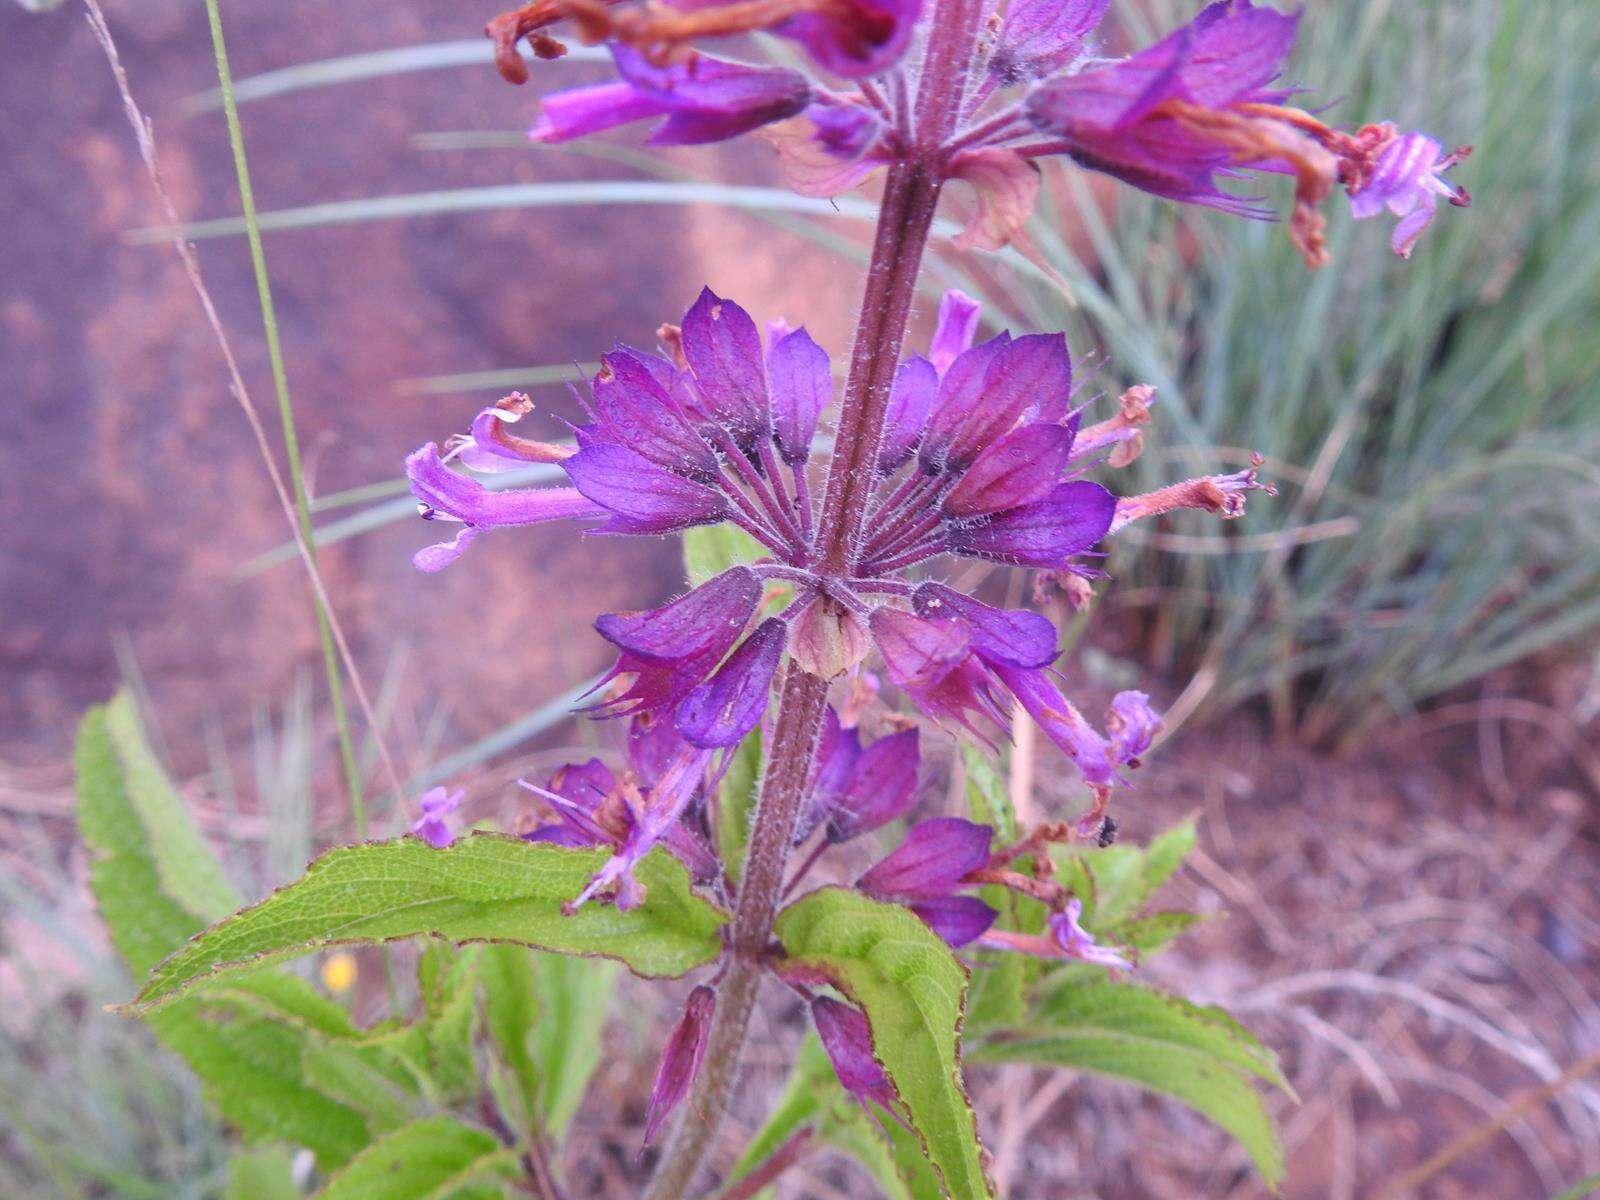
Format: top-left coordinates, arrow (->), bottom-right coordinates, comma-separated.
131,834 -> 723,1011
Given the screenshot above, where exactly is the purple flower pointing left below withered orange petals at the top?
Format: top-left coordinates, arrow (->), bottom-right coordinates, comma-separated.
528,43 -> 811,146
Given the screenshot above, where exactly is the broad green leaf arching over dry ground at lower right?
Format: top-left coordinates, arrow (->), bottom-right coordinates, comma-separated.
968,979 -> 1293,1187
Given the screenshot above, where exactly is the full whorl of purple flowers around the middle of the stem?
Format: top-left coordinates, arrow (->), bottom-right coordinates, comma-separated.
406,290 -> 1261,904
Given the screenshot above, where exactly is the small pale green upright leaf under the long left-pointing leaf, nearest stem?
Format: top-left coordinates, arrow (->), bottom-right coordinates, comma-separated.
533,954 -> 618,1142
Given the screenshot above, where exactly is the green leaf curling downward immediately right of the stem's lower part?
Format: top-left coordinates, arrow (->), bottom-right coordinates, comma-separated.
774,888 -> 989,1200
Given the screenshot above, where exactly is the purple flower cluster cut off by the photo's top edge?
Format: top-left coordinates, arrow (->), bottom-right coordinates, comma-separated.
490,0 -> 1470,267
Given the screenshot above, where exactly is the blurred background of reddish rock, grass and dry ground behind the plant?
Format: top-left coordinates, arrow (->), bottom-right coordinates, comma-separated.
0,0 -> 1600,1200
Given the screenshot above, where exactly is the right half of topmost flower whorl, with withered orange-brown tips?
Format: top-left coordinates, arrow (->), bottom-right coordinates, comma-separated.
1011,0 -> 1467,267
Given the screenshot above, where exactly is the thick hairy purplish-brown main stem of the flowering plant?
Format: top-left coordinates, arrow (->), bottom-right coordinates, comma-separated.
646,0 -> 981,1200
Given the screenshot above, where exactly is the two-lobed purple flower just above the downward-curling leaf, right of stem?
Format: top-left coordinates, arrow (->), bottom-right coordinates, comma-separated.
856,816 -> 995,946
